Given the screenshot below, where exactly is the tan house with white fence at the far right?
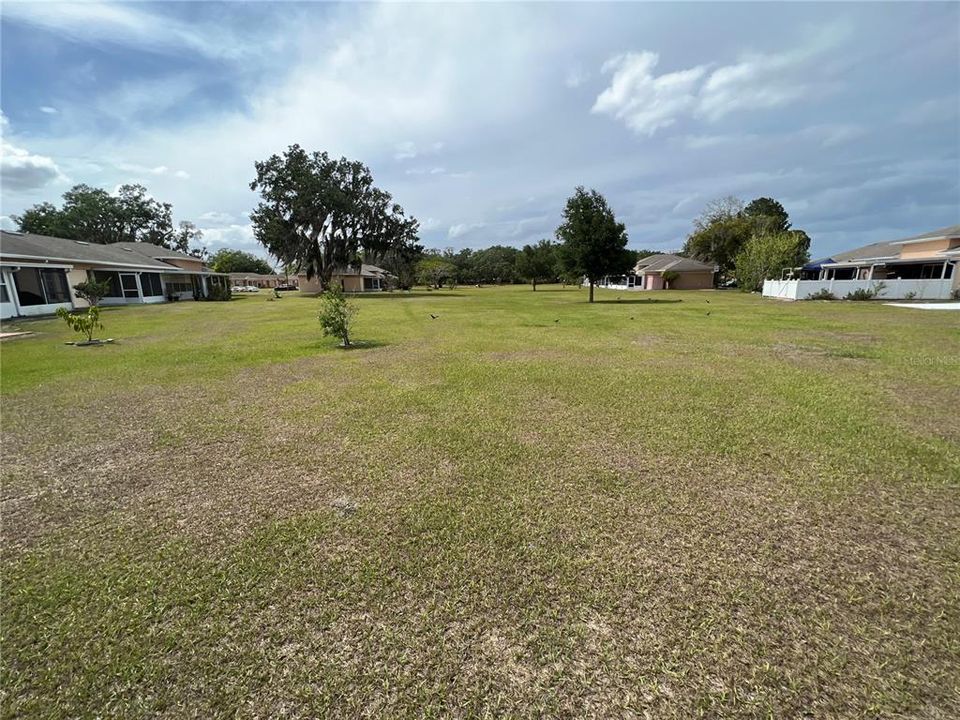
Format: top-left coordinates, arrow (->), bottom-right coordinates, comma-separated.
763,225 -> 960,300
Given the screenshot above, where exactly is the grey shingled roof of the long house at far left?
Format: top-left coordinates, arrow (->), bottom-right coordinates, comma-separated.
0,230 -> 219,273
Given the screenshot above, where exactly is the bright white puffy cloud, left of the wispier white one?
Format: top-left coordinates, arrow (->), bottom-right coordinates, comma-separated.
591,52 -> 706,135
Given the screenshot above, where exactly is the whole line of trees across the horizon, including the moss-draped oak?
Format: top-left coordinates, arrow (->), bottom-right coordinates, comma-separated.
14,145 -> 810,301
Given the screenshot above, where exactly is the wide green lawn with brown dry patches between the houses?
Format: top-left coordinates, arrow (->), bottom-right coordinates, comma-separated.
0,287 -> 960,718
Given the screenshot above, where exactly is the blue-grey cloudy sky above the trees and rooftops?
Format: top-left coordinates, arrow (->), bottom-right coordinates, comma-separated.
0,1 -> 960,255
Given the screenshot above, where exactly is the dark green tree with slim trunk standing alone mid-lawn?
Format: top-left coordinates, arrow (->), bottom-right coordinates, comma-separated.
557,187 -> 632,302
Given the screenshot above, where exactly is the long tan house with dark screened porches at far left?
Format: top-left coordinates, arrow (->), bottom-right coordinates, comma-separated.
0,230 -> 228,318
